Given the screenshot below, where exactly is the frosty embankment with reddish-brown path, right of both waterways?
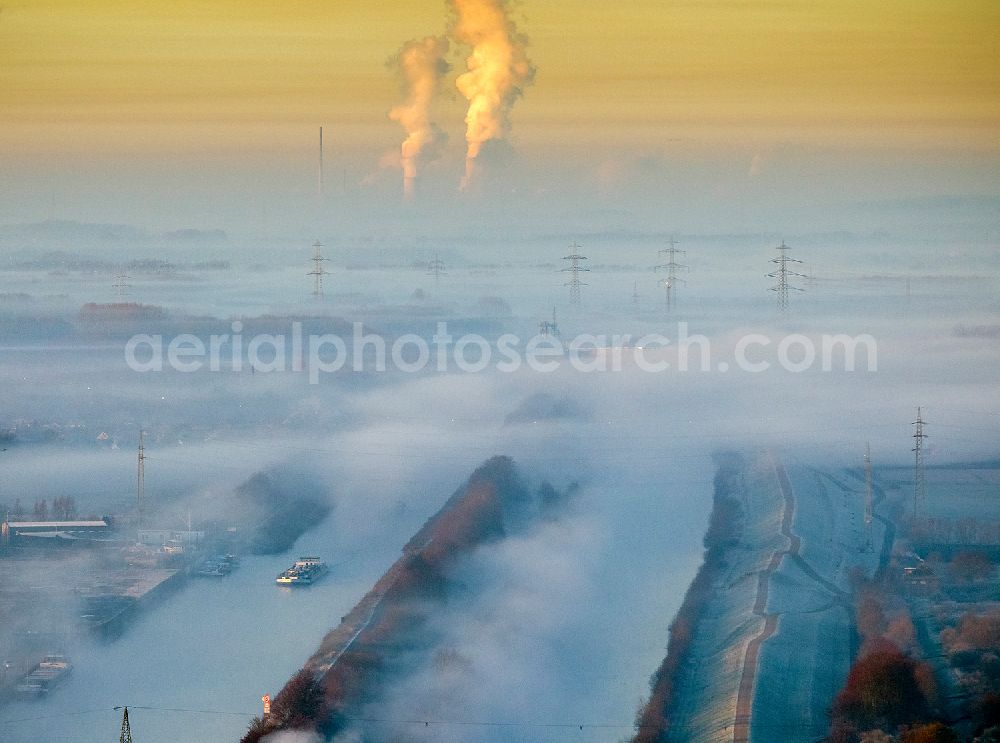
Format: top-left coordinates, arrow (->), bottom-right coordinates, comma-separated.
634,453 -> 885,743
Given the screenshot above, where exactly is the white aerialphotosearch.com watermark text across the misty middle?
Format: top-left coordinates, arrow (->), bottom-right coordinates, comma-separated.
125,320 -> 878,384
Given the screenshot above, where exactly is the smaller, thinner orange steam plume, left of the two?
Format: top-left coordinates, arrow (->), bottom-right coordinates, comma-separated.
389,36 -> 448,199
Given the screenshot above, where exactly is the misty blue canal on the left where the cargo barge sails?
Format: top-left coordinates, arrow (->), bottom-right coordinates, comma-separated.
0,506 -> 423,743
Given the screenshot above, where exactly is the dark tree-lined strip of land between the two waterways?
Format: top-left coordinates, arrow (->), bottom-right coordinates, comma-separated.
237,456 -> 564,743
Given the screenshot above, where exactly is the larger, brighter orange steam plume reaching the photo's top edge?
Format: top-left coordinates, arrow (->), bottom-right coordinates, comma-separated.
450,0 -> 535,189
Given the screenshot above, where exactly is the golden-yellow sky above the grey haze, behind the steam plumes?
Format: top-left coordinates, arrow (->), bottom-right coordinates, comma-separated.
0,0 -> 1000,155
